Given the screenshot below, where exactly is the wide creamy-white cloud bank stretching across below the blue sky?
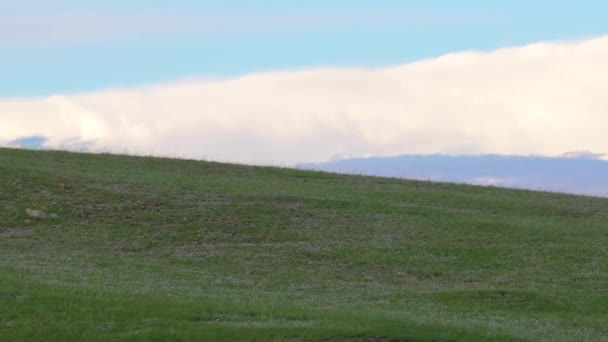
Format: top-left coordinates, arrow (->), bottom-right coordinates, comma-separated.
0,36 -> 608,164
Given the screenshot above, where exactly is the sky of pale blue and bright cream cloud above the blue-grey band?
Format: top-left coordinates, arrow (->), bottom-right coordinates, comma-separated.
0,0 -> 608,165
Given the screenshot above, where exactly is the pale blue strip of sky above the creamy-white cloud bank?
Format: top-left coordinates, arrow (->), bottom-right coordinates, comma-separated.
0,0 -> 608,98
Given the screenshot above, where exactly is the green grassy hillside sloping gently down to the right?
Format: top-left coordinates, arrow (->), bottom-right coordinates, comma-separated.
0,149 -> 608,341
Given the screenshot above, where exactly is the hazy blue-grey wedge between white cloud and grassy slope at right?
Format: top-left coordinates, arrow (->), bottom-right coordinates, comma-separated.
298,153 -> 608,197
